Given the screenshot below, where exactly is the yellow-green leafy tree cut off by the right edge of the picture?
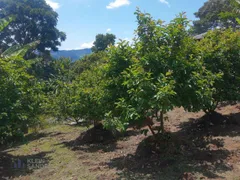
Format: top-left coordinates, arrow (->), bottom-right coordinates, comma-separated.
198,28 -> 240,112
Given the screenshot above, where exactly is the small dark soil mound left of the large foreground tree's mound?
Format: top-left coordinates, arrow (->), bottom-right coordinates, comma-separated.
75,124 -> 120,145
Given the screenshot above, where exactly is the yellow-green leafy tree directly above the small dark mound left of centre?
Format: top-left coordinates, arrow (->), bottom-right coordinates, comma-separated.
71,64 -> 107,125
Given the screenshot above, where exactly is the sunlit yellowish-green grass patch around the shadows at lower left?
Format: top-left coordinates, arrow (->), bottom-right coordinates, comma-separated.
1,125 -> 100,180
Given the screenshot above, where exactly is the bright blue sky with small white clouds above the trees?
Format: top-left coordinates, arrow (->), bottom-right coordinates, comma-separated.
46,0 -> 206,50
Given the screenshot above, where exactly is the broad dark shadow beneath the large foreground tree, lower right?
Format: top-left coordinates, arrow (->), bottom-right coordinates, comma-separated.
107,114 -> 239,180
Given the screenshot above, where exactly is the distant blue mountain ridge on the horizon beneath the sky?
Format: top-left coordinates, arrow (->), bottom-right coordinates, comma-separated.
51,49 -> 92,62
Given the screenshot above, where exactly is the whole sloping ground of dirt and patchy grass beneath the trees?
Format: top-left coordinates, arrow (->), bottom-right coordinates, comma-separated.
0,104 -> 240,180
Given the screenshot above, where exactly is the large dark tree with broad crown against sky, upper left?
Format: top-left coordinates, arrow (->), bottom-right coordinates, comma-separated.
0,0 -> 66,52
